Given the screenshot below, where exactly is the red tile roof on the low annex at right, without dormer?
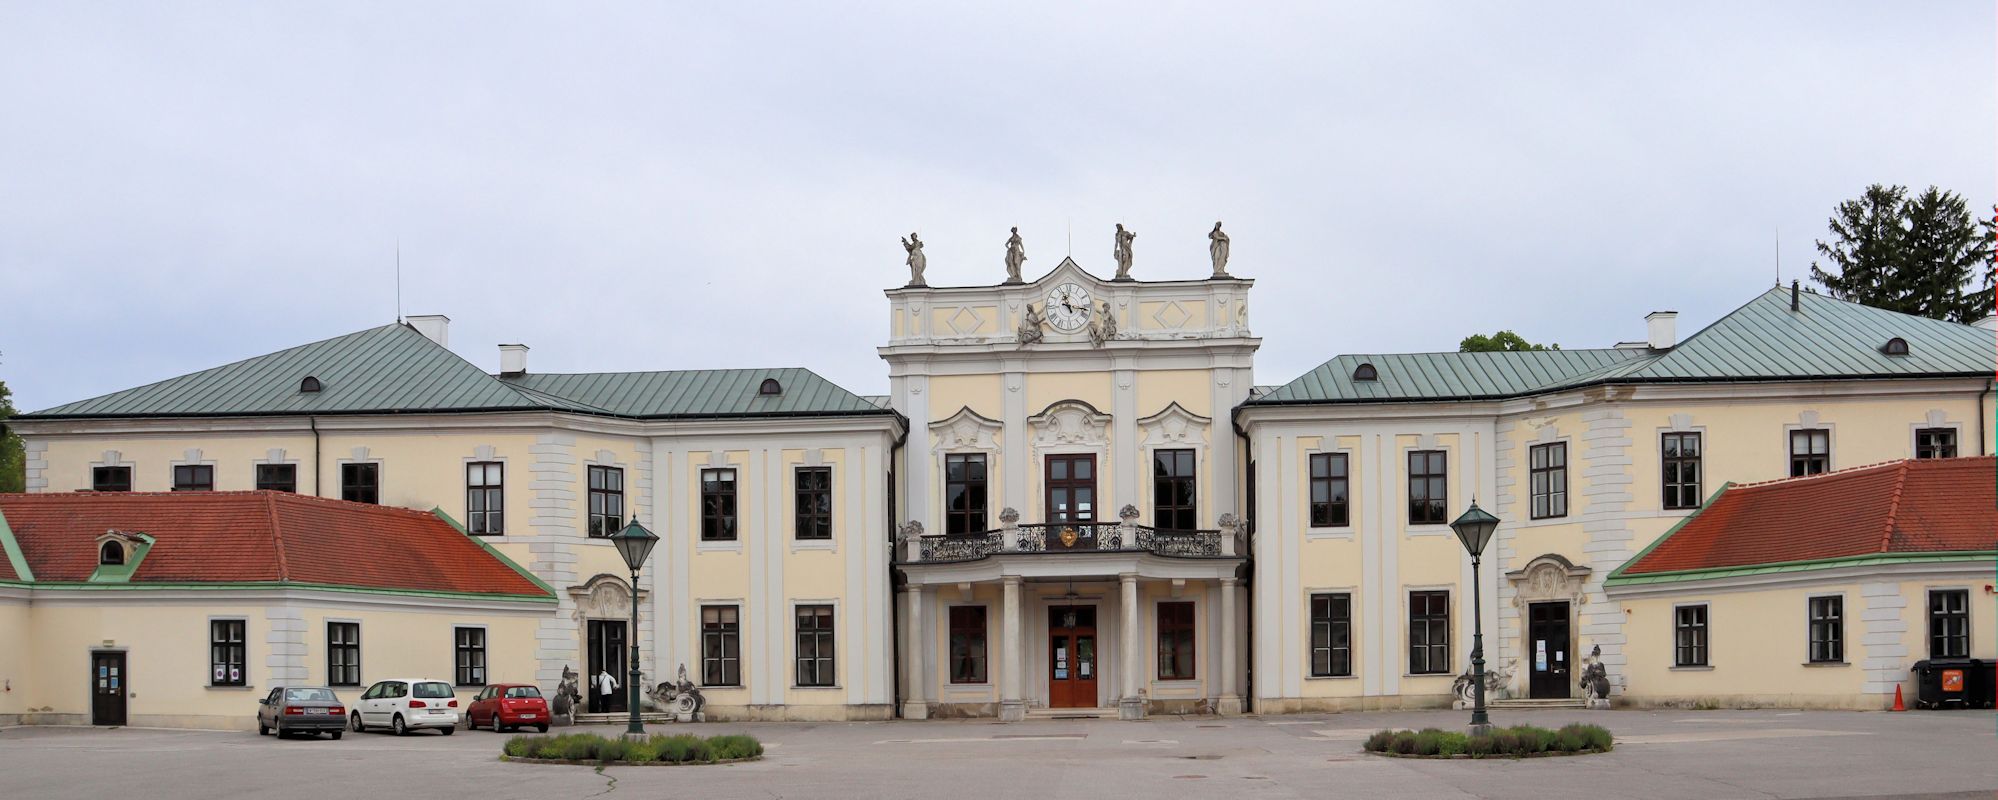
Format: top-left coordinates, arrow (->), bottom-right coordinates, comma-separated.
1620,456 -> 1998,576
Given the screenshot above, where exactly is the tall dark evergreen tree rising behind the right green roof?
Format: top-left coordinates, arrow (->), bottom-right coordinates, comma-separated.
1810,184 -> 1992,322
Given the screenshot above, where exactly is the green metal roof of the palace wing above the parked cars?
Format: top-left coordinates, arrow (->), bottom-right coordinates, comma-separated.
16,324 -> 893,420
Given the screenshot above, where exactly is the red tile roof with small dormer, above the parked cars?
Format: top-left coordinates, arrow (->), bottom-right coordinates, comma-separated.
0,492 -> 549,598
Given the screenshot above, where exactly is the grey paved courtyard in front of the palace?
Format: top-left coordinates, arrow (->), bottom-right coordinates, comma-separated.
0,710 -> 1998,800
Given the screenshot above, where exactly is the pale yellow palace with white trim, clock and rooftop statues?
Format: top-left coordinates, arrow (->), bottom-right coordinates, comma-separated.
0,247 -> 1998,722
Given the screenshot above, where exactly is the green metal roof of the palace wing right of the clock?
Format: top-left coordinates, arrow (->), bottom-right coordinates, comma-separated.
1249,288 -> 1994,406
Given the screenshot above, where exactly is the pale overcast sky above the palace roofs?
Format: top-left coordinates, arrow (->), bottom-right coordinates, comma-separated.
0,0 -> 1998,412
